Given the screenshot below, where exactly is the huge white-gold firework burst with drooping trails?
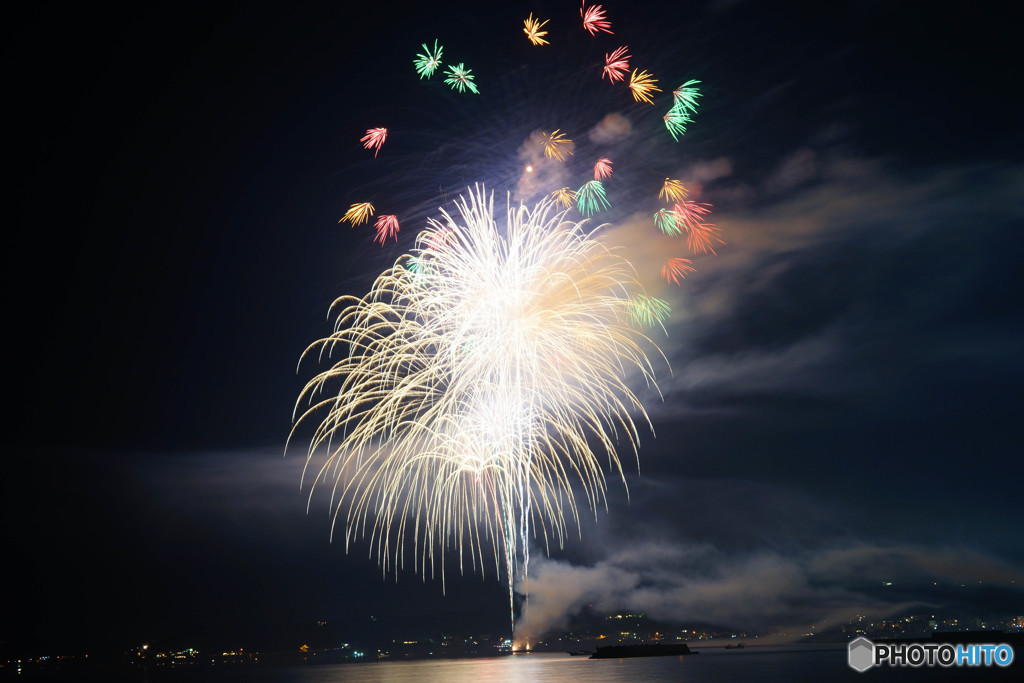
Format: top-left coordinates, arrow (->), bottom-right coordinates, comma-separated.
293,186 -> 664,626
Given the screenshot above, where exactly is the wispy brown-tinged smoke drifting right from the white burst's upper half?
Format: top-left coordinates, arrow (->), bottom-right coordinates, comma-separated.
605,153 -> 1024,414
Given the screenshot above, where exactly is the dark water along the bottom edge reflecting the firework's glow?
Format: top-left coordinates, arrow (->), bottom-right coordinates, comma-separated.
136,645 -> 1024,683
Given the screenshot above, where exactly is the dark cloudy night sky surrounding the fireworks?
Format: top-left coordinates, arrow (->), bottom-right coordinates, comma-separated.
0,0 -> 1024,649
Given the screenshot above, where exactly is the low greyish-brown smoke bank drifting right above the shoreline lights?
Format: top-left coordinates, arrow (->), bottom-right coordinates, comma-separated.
516,542 -> 1021,639
